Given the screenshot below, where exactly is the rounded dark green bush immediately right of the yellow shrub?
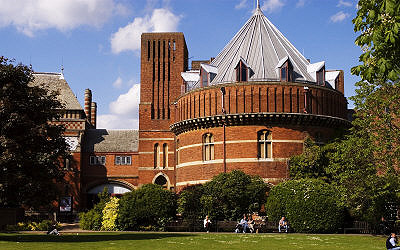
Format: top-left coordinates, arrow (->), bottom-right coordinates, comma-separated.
117,184 -> 176,230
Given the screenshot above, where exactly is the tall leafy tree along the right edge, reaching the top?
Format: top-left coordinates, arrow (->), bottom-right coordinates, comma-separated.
352,0 -> 400,175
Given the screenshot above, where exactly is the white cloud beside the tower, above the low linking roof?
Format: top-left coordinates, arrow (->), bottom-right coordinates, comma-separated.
97,82 -> 140,129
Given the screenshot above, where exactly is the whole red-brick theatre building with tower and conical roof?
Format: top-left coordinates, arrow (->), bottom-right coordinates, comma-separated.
32,4 -> 350,210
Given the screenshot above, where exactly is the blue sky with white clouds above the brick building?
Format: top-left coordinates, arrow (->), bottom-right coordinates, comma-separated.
0,0 -> 361,129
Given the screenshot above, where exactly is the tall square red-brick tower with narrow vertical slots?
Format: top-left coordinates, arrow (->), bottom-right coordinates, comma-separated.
139,33 -> 188,189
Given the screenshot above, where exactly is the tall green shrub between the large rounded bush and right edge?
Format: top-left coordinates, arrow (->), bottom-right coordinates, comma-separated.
326,134 -> 400,222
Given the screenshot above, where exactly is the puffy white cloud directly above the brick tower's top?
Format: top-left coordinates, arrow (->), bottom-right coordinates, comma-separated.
111,9 -> 181,54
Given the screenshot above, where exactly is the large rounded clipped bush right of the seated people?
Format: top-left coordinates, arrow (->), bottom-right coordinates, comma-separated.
266,179 -> 344,233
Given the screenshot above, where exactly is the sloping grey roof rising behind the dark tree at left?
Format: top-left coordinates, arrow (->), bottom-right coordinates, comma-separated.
32,72 -> 83,110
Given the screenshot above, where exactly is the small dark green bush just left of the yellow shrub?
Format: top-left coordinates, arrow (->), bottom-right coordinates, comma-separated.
79,187 -> 110,231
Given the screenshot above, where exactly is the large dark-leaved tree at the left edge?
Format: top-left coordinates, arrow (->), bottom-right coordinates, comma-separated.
0,57 -> 67,207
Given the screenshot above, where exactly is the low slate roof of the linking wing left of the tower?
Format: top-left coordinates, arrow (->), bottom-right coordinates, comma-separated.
82,129 -> 139,153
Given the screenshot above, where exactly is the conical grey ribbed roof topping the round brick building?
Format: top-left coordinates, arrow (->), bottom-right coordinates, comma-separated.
211,8 -> 315,84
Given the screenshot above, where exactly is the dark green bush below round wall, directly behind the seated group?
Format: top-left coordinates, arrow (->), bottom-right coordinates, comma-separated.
200,170 -> 269,220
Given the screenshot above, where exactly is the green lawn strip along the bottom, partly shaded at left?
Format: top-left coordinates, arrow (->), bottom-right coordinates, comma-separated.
0,233 -> 386,250
